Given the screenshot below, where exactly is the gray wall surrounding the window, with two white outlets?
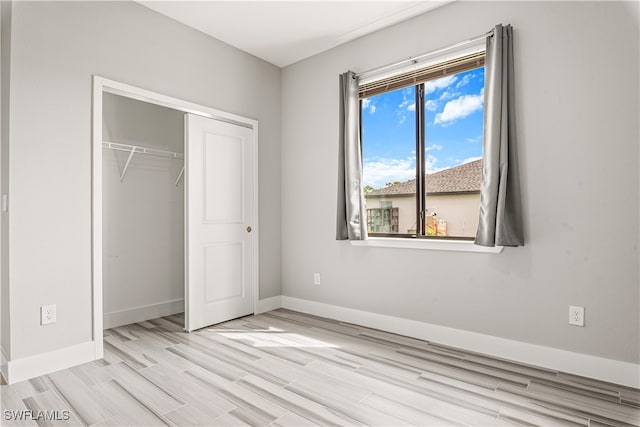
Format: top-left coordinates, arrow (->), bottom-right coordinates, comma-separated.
282,2 -> 640,363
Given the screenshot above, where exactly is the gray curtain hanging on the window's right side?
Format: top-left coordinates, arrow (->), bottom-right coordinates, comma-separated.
475,25 -> 524,246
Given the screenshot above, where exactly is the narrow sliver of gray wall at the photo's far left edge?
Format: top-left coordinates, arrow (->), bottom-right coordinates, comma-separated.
0,1 -> 12,357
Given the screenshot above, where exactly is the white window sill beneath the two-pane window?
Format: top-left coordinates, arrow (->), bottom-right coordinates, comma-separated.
349,237 -> 503,254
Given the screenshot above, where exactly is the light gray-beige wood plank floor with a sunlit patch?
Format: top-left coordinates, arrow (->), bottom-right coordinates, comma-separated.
1,309 -> 640,427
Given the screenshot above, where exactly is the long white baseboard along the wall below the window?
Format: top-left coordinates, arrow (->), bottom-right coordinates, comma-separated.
281,295 -> 640,388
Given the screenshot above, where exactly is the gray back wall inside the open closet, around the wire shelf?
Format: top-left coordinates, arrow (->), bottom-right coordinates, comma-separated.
102,94 -> 184,326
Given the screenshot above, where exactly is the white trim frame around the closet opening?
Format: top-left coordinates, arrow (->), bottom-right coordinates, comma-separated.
91,75 -> 260,360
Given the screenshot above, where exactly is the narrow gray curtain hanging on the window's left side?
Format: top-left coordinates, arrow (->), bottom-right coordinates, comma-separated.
336,71 -> 367,240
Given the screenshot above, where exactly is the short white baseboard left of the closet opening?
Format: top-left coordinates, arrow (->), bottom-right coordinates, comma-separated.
2,341 -> 96,384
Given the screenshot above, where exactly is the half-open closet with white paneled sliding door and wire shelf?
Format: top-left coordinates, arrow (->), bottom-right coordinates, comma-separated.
99,88 -> 258,334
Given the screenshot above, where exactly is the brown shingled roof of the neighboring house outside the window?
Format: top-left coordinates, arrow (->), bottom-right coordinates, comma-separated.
365,160 -> 482,197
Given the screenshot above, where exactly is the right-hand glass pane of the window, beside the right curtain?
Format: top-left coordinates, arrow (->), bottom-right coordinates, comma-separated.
424,67 -> 484,238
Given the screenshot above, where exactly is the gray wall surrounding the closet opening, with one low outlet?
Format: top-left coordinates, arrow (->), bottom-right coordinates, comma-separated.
5,2 -> 280,359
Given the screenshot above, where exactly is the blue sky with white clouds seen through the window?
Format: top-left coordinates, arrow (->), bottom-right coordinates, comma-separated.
362,68 -> 484,188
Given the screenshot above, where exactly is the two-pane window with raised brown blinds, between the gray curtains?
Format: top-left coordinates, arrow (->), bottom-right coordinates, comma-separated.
359,51 -> 484,240
